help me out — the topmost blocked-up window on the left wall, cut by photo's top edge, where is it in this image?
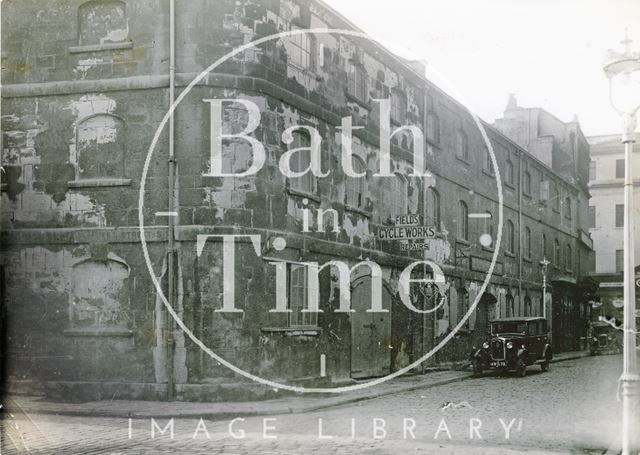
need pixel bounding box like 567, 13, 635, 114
78, 0, 129, 46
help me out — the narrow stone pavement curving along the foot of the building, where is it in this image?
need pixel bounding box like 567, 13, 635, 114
4, 351, 589, 420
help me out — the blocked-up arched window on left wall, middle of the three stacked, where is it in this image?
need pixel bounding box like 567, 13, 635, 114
76, 114, 125, 180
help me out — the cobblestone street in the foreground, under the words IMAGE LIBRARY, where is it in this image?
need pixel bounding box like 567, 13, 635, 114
2, 356, 621, 455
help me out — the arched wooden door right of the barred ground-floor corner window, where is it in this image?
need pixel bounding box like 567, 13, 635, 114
351, 277, 391, 379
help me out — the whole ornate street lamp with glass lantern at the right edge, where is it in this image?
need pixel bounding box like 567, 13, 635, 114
603, 33, 640, 455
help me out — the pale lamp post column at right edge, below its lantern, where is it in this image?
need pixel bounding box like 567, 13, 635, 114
620, 114, 640, 455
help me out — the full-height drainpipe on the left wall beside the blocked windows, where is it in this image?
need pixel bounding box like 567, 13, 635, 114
167, 0, 176, 401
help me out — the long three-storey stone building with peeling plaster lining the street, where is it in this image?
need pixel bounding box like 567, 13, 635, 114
1, 0, 593, 400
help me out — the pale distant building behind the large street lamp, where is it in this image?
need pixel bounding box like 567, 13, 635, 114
587, 134, 640, 319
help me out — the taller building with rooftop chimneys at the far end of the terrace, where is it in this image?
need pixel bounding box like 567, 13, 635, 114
494, 94, 594, 349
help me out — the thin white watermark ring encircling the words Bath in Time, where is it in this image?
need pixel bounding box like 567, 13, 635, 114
138, 28, 503, 393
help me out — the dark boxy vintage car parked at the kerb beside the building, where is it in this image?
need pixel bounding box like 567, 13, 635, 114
470, 317, 553, 377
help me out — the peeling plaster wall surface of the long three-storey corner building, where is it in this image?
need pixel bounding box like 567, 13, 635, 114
0, 0, 592, 400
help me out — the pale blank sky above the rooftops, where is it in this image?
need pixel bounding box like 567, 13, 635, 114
324, 0, 640, 136
